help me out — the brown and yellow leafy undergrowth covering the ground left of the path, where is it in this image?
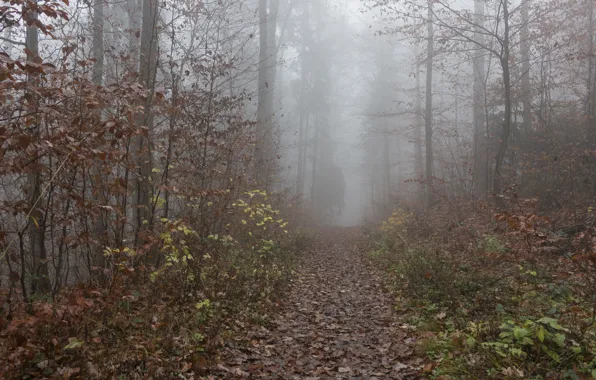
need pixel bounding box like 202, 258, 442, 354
0, 191, 311, 379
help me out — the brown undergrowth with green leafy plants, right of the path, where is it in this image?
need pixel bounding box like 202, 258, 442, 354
368, 200, 596, 380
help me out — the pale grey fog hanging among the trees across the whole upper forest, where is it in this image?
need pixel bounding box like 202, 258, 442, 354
2, 0, 596, 236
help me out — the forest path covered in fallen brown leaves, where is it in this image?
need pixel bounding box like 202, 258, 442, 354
212, 229, 417, 380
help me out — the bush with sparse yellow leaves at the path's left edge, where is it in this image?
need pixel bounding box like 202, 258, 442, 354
152, 190, 296, 308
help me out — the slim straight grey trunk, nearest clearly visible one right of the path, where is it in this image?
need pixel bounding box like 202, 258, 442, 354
424, 0, 434, 207
